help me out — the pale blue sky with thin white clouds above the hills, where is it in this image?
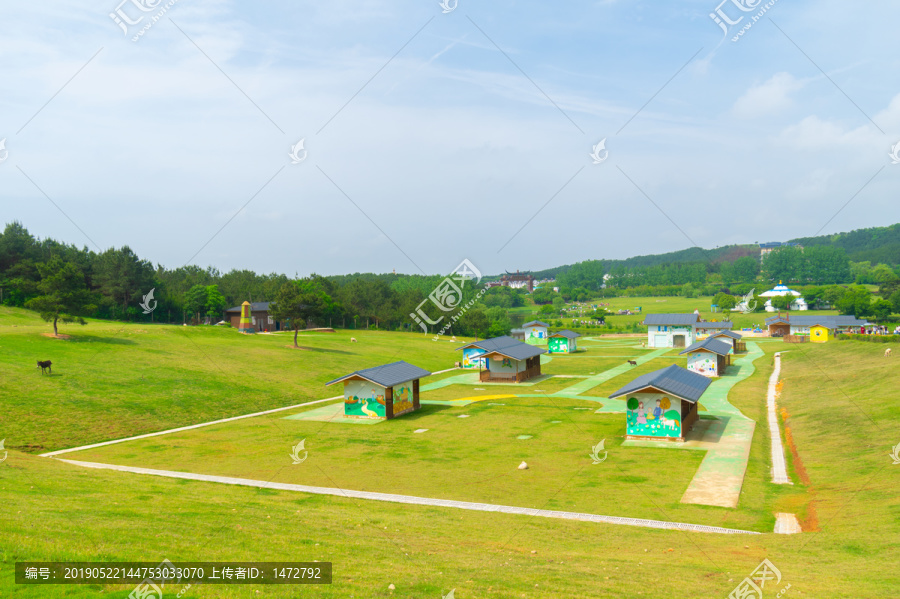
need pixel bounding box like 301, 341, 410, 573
0, 0, 900, 275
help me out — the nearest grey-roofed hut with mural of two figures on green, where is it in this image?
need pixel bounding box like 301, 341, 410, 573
609, 364, 711, 441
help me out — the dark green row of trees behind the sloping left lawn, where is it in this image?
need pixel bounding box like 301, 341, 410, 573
0, 222, 523, 336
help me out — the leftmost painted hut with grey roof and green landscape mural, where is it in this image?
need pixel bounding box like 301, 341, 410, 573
325, 360, 431, 420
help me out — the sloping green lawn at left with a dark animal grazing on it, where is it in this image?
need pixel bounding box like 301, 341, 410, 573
0, 307, 460, 453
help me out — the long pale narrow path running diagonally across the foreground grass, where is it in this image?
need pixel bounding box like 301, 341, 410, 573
60, 459, 760, 535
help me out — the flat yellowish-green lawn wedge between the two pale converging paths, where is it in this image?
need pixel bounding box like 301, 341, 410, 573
65, 397, 752, 530
